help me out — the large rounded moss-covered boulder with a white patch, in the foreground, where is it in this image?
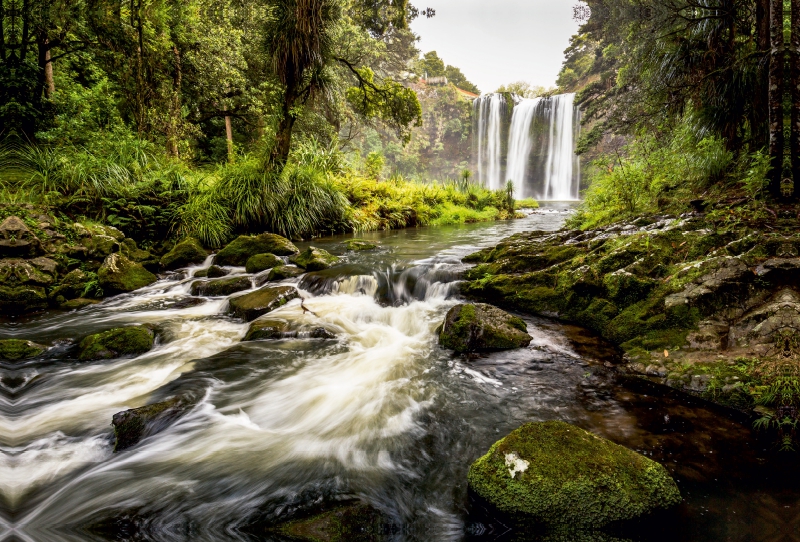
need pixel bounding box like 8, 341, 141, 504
468, 421, 681, 529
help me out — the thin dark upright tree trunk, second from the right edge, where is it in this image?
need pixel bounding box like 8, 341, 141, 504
769, 0, 785, 198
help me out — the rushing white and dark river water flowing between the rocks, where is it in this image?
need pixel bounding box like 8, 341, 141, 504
0, 209, 800, 541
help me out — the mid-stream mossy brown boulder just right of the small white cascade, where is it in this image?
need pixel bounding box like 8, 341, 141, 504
439, 303, 532, 353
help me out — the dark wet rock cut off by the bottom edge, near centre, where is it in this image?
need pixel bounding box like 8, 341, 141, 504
277, 504, 393, 542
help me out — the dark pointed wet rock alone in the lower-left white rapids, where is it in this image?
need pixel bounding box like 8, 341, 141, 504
111, 396, 194, 452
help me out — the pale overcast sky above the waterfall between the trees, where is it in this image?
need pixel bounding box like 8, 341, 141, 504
412, 0, 578, 92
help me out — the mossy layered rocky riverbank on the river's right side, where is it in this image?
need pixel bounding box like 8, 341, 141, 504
462, 208, 800, 422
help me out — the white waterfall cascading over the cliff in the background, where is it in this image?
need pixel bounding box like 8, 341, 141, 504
474, 94, 580, 201
